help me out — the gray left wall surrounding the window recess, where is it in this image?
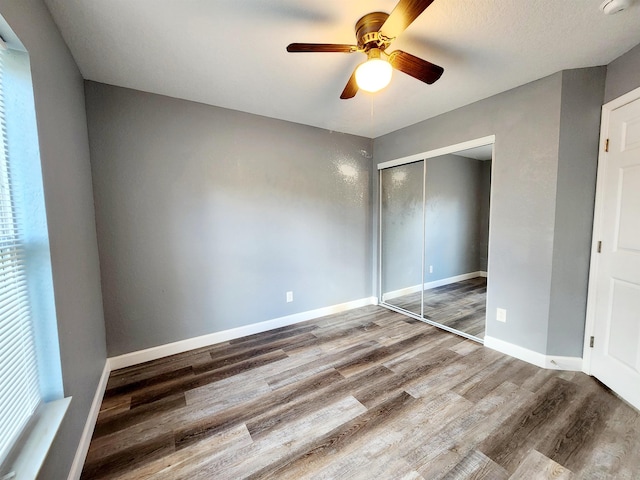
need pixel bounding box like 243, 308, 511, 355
0, 0, 106, 480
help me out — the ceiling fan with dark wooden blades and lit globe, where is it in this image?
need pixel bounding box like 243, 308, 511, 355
287, 0, 444, 100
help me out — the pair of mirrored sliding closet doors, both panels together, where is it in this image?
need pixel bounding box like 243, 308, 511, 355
380, 139, 493, 341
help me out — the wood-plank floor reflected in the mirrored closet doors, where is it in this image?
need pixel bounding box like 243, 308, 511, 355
387, 277, 487, 339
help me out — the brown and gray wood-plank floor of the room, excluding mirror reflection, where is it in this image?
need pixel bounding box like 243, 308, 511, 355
82, 307, 640, 480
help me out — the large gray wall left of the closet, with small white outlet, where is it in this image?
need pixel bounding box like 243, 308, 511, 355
86, 82, 372, 356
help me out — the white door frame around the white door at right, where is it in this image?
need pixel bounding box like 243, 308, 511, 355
582, 87, 640, 375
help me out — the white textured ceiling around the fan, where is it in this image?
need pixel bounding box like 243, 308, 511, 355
45, 0, 640, 138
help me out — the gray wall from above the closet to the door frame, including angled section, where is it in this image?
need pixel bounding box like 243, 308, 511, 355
374, 67, 604, 356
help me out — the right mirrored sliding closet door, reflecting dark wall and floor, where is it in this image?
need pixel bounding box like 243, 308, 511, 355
422, 152, 492, 340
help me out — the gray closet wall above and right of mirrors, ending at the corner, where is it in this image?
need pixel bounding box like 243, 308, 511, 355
374, 73, 562, 353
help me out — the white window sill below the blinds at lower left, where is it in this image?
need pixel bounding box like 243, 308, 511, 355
8, 397, 71, 480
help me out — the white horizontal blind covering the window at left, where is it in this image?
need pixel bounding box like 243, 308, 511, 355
0, 45, 41, 463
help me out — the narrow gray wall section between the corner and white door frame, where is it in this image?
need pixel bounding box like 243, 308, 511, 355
547, 67, 606, 357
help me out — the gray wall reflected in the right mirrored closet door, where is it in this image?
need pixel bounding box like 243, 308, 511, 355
424, 155, 489, 282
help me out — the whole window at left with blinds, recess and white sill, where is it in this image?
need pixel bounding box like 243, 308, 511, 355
0, 20, 70, 479
